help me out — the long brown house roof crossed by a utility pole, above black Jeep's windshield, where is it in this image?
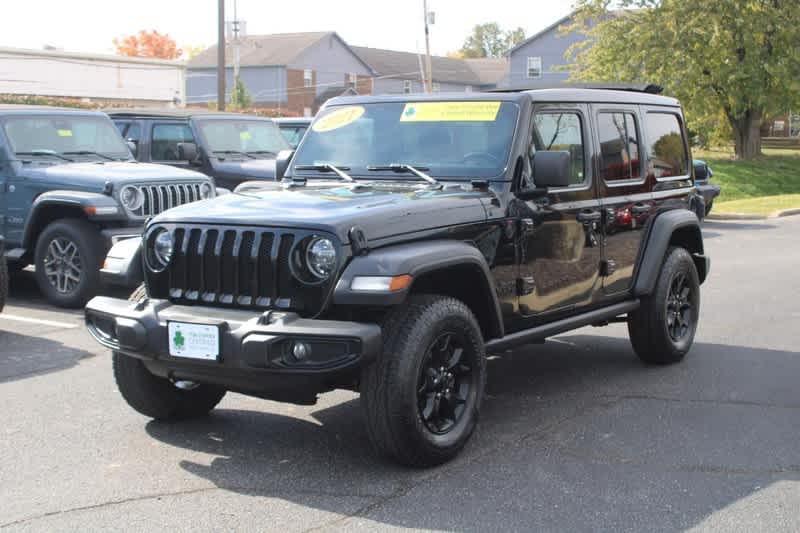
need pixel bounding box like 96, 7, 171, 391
352, 46, 488, 85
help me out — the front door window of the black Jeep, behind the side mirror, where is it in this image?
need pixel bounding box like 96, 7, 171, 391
530, 112, 585, 185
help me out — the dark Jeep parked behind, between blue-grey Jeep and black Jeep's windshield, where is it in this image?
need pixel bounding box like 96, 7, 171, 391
108, 109, 291, 189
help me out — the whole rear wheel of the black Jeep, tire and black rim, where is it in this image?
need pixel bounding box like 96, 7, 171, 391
628, 248, 700, 365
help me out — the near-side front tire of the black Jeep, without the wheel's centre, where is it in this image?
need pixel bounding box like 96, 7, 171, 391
360, 295, 486, 467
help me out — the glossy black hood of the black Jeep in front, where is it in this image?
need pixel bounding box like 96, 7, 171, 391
149, 182, 492, 243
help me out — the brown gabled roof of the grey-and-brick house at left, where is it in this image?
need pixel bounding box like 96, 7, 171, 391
187, 31, 374, 68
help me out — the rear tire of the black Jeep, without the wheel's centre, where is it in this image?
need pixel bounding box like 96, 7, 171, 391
628, 247, 700, 365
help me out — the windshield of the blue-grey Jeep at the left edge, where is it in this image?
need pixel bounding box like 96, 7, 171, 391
4, 115, 130, 159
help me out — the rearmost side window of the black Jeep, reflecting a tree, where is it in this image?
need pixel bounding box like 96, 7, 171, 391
645, 113, 689, 178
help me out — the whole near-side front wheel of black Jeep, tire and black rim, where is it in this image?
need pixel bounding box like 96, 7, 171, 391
361, 295, 486, 466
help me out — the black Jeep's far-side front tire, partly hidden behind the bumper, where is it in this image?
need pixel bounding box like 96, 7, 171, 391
112, 283, 225, 421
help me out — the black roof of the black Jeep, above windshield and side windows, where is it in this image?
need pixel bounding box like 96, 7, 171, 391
326, 88, 680, 107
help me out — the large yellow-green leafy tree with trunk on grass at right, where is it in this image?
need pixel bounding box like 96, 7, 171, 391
567, 0, 800, 159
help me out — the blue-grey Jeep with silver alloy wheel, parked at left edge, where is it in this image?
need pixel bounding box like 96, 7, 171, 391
0, 105, 215, 307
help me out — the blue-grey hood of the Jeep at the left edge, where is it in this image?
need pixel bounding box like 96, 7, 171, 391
20, 161, 208, 190
